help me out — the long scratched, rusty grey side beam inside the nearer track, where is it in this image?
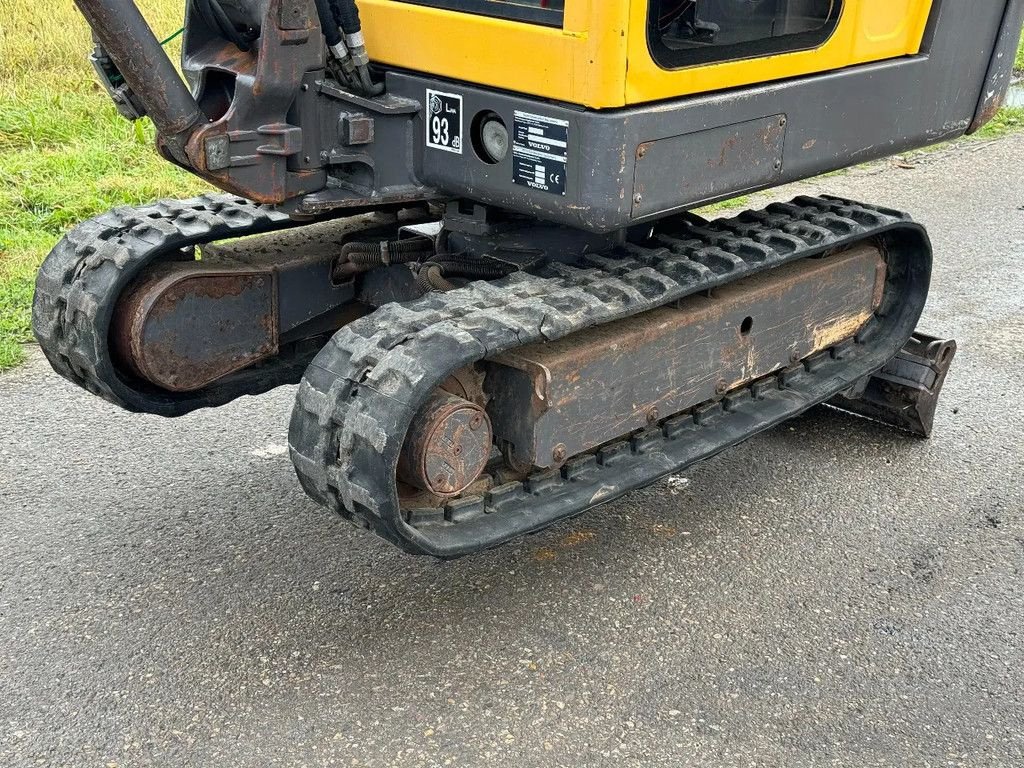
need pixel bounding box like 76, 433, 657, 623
487, 245, 886, 470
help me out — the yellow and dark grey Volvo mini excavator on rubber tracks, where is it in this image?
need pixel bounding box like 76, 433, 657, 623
33, 0, 1024, 558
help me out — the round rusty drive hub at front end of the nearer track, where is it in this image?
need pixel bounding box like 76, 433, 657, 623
398, 391, 492, 498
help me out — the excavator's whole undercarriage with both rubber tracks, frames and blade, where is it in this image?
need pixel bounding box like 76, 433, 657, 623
35, 196, 954, 557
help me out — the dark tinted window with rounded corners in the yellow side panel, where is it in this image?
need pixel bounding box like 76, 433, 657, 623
649, 0, 843, 69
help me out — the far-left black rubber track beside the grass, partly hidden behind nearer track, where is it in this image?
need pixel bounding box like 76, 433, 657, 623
32, 195, 312, 416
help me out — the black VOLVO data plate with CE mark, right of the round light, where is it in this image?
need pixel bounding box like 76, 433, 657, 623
512, 111, 569, 195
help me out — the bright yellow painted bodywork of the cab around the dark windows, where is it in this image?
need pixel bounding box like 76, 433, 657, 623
359, 0, 933, 109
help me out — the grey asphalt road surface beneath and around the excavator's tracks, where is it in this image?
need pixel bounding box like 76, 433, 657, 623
0, 136, 1024, 768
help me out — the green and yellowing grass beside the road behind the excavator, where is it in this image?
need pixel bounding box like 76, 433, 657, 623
0, 9, 1024, 371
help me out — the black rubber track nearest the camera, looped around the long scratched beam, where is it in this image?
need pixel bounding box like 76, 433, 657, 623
289, 198, 931, 557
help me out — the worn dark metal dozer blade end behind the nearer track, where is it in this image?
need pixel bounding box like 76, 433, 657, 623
828, 333, 956, 437
